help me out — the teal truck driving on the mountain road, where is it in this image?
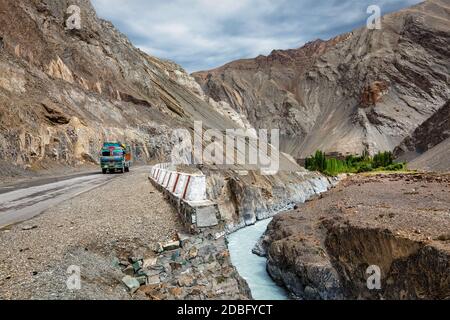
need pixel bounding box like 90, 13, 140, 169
100, 142, 132, 174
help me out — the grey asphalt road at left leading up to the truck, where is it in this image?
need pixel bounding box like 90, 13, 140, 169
0, 172, 118, 229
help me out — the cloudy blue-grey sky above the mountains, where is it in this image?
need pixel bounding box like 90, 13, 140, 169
92, 0, 421, 72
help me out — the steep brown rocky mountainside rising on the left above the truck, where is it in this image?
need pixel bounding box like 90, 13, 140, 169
0, 0, 253, 172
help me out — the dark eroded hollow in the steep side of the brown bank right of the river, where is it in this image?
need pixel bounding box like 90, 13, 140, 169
325, 225, 450, 300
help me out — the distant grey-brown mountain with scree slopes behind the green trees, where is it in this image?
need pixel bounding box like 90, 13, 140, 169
193, 0, 450, 158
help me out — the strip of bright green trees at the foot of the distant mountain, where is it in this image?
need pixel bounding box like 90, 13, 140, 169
305, 151, 406, 176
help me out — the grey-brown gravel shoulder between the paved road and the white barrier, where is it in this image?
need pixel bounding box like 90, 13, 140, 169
0, 170, 182, 299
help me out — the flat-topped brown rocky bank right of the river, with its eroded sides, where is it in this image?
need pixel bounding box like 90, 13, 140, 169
263, 174, 450, 300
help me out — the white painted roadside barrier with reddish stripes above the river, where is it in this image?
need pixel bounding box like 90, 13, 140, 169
150, 163, 207, 202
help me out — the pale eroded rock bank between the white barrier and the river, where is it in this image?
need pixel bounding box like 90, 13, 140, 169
203, 168, 338, 232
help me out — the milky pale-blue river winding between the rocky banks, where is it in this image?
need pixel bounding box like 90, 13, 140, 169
228, 219, 289, 300
